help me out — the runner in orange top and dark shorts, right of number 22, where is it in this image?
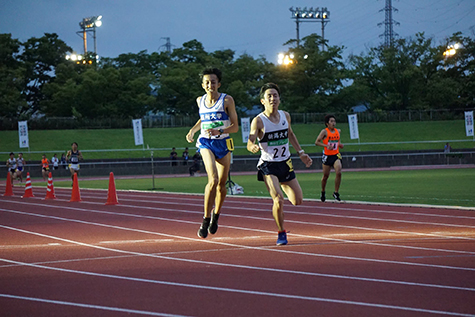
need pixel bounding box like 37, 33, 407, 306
315, 114, 343, 202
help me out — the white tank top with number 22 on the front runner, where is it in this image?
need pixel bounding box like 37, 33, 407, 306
258, 110, 290, 166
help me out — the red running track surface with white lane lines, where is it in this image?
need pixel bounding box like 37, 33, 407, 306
0, 185, 475, 316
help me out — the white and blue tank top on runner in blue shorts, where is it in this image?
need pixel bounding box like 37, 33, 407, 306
198, 93, 231, 140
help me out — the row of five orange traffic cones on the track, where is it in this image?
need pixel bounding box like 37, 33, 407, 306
3, 172, 119, 205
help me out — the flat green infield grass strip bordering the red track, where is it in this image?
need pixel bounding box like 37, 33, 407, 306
55, 168, 475, 207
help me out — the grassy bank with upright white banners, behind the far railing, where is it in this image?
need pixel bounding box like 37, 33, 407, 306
0, 120, 475, 161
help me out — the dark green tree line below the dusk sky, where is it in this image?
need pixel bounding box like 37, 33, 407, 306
0, 33, 475, 119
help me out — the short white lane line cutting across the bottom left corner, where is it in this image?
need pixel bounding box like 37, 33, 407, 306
0, 294, 190, 317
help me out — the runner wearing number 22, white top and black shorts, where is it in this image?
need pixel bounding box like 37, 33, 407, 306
247, 83, 312, 245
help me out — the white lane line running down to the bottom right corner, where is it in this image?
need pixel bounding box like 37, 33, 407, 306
0, 259, 474, 316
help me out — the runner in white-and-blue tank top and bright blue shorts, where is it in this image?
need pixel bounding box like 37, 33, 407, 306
186, 68, 239, 238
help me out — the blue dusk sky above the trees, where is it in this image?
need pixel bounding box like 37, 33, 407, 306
0, 0, 475, 63
